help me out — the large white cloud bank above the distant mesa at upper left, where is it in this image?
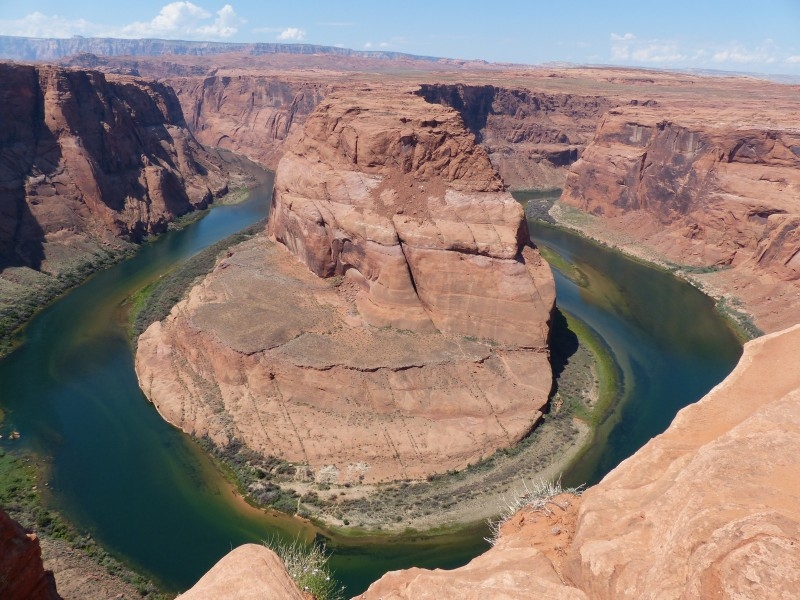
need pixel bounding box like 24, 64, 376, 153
0, 1, 245, 39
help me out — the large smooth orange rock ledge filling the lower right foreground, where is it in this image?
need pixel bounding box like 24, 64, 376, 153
361, 326, 800, 600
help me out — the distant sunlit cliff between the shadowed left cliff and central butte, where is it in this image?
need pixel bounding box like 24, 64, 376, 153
166, 73, 329, 169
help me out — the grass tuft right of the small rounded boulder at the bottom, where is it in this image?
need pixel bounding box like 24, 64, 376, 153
264, 539, 344, 600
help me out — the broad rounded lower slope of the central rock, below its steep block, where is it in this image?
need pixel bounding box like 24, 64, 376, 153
136, 238, 550, 483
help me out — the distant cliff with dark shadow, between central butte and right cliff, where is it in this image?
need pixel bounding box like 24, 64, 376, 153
419, 84, 619, 189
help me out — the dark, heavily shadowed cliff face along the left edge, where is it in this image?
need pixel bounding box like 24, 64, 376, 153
0, 64, 224, 269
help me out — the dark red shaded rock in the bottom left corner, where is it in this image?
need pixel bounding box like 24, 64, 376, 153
0, 509, 61, 600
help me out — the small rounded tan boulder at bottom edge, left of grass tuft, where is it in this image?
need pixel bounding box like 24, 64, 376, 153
178, 544, 306, 600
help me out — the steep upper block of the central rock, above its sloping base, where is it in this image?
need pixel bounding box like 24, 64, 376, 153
269, 90, 553, 348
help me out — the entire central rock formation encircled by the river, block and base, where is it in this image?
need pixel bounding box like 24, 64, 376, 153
136, 90, 554, 482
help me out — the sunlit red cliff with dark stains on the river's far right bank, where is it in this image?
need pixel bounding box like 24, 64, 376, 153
562, 106, 800, 330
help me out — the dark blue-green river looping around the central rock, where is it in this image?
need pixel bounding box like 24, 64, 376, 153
0, 186, 741, 594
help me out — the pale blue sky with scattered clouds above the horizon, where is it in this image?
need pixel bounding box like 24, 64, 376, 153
0, 0, 800, 75
